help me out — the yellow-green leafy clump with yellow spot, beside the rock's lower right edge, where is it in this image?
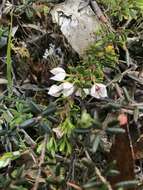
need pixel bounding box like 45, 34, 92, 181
83, 37, 118, 82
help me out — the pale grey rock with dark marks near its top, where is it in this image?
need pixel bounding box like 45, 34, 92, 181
51, 0, 100, 55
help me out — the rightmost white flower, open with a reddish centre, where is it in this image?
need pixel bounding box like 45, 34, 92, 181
90, 83, 108, 99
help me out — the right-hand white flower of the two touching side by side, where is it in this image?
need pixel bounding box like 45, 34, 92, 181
63, 82, 75, 97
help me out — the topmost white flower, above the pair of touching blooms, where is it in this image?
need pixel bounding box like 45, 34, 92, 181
50, 67, 66, 81
